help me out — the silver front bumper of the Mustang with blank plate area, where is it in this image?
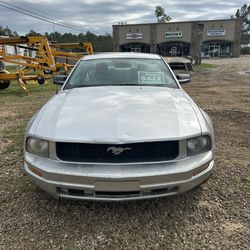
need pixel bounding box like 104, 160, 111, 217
24, 151, 214, 201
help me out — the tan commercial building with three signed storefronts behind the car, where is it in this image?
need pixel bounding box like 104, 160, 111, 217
113, 19, 241, 57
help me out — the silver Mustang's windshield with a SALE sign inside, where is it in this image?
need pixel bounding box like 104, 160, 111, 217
64, 58, 178, 89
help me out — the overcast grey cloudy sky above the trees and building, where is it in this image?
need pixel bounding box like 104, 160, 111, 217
0, 0, 246, 34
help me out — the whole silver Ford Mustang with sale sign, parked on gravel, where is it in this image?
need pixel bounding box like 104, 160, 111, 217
24, 53, 214, 201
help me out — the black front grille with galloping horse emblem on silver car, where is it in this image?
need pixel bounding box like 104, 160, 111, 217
56, 141, 179, 163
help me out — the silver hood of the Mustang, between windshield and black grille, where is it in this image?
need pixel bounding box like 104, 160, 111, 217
33, 86, 201, 144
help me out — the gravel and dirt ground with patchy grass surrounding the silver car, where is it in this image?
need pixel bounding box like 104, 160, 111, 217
0, 57, 250, 249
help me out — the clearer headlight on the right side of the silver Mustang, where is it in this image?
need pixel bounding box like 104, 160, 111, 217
187, 135, 212, 155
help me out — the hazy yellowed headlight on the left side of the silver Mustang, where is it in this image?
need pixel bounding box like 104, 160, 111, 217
26, 137, 49, 157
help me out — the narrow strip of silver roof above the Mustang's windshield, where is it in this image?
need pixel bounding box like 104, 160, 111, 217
82, 52, 161, 60
